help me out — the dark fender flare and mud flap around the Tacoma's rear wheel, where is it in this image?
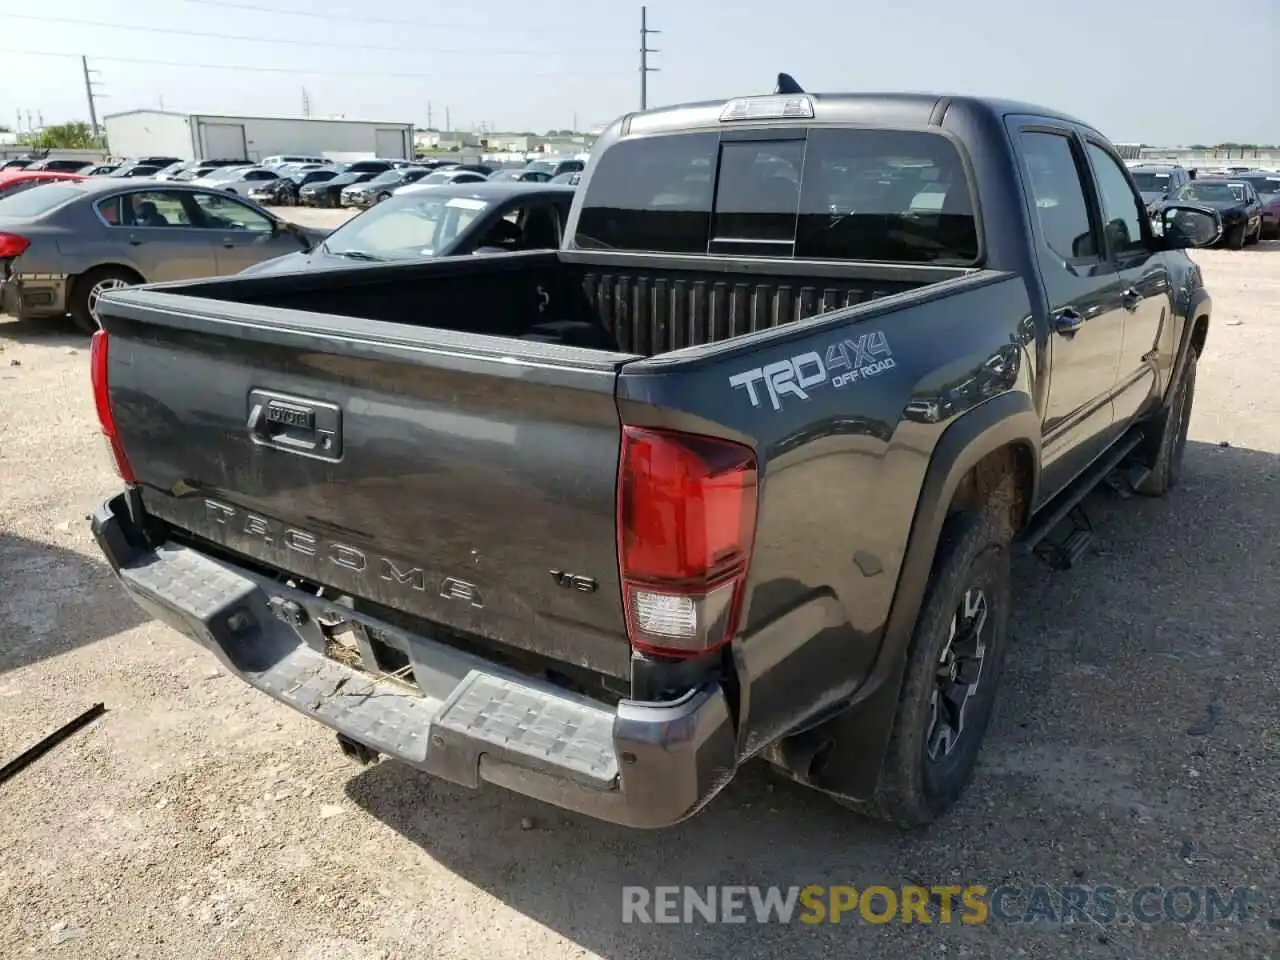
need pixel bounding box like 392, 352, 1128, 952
792, 392, 1041, 800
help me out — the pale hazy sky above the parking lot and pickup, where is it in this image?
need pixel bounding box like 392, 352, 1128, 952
0, 0, 1280, 146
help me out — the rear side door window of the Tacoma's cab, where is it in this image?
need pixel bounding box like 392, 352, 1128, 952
1020, 131, 1098, 260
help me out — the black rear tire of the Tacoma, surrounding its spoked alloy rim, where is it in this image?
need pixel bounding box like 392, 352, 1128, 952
841, 509, 1011, 827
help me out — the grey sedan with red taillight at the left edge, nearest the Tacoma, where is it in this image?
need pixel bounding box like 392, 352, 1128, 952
0, 178, 325, 332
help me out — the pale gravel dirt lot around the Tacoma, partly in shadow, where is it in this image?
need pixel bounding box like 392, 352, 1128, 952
0, 236, 1280, 960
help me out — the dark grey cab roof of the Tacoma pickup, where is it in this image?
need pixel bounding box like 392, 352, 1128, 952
605, 92, 1091, 136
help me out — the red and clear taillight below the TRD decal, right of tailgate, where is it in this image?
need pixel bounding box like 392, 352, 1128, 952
618, 426, 756, 657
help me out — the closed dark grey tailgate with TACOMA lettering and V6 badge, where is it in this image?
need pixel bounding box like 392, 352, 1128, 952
102, 289, 630, 677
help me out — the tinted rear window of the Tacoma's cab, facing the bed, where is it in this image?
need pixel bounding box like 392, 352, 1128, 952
575, 128, 979, 265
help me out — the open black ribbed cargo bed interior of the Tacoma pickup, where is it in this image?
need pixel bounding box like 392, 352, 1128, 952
142, 251, 973, 357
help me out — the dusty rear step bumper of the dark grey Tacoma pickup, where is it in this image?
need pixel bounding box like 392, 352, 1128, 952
91, 495, 736, 827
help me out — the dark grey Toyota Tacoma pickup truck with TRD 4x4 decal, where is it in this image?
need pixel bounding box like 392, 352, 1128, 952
91, 74, 1221, 827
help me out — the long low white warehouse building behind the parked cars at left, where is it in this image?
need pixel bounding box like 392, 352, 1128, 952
102, 110, 413, 160
